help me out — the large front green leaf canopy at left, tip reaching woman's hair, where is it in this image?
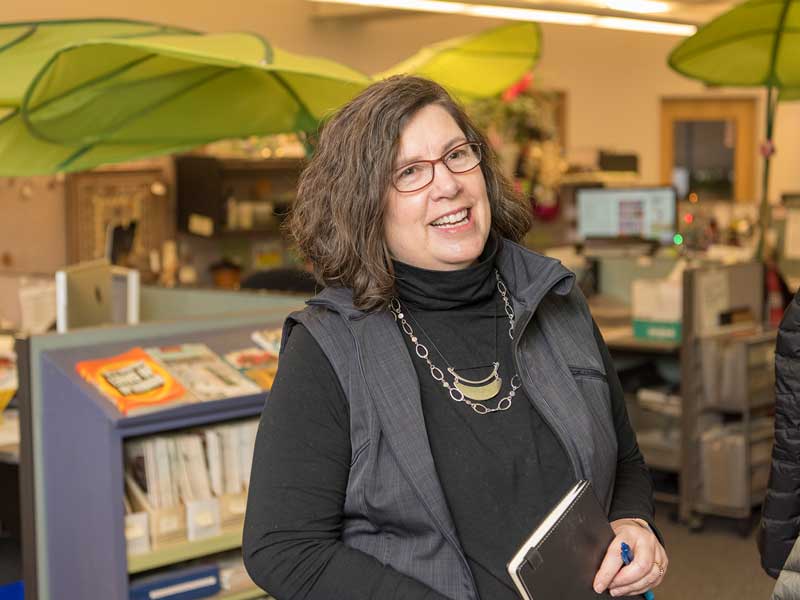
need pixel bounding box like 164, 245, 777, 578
0, 26, 369, 174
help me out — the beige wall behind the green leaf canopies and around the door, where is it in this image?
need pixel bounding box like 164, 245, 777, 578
0, 0, 800, 198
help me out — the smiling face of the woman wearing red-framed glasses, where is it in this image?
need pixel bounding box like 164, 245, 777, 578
383, 104, 492, 271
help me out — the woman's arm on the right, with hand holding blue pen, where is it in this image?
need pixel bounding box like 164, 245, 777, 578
594, 324, 669, 595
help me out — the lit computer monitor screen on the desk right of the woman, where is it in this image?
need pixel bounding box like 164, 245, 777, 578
576, 186, 677, 244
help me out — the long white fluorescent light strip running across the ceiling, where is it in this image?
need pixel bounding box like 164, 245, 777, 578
312, 0, 697, 36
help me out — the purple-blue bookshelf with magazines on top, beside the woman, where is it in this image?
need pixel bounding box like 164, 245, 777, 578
26, 304, 302, 600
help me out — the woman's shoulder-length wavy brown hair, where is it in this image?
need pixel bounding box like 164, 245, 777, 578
287, 75, 532, 311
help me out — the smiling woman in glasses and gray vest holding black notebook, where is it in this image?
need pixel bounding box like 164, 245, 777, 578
243, 77, 667, 600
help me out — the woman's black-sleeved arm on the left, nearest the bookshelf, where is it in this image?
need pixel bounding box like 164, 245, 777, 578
242, 325, 454, 600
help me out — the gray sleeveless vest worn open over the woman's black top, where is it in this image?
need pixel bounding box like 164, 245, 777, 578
284, 241, 617, 600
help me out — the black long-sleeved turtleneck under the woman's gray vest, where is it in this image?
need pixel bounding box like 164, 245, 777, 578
245, 240, 653, 600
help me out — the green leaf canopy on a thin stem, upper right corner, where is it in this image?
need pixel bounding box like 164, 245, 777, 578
669, 0, 800, 255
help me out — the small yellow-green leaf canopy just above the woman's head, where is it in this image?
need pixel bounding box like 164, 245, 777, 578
375, 23, 541, 102
